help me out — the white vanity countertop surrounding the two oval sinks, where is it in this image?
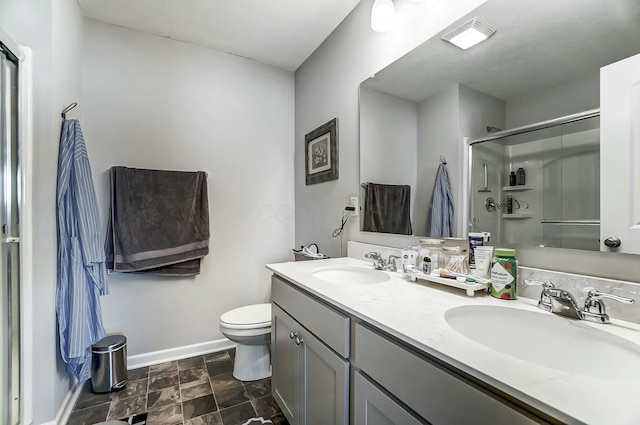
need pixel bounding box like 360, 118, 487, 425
267, 257, 640, 425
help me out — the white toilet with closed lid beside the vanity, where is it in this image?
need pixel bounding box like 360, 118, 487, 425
220, 303, 271, 381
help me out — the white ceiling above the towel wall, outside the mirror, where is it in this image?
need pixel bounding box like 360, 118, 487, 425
78, 0, 360, 71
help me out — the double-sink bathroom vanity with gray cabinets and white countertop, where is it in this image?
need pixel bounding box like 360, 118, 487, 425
267, 258, 640, 425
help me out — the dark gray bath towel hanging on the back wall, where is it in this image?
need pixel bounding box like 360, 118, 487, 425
105, 167, 209, 276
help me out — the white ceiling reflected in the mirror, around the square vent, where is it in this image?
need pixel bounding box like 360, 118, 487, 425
365, 0, 640, 102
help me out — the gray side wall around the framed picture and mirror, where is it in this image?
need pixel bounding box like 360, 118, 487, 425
295, 0, 484, 256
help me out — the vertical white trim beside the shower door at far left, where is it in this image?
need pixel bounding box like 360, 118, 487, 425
18, 44, 34, 424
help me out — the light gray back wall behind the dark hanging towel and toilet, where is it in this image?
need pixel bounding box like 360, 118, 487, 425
82, 20, 294, 355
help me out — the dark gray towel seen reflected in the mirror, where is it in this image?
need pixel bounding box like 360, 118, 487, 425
362, 183, 413, 235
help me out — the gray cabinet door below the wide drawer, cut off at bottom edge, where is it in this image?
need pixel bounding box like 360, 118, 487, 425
353, 372, 425, 425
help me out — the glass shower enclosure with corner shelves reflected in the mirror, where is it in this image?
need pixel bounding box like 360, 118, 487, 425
469, 111, 600, 251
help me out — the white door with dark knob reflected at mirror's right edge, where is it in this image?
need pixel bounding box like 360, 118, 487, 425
600, 55, 640, 254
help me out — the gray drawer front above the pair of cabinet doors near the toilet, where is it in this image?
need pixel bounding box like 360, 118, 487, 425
271, 275, 349, 359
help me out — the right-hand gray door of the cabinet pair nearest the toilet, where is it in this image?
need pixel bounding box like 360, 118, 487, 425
300, 326, 349, 425
